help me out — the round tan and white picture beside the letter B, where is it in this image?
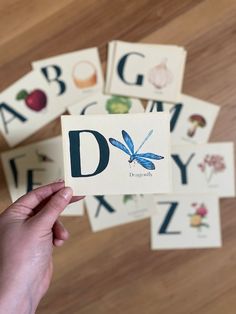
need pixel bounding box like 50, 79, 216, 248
72, 61, 97, 89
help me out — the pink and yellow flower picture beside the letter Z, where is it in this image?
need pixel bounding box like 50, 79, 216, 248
189, 203, 209, 230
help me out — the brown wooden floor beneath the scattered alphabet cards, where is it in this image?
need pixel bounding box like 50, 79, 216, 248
0, 0, 236, 314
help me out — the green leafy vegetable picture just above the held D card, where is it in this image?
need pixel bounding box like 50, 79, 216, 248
106, 96, 132, 113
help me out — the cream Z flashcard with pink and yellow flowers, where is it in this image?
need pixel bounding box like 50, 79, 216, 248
151, 194, 222, 250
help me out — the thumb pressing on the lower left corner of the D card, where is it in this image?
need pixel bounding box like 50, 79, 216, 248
31, 187, 73, 229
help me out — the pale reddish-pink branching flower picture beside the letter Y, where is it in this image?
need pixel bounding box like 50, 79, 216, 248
198, 155, 226, 183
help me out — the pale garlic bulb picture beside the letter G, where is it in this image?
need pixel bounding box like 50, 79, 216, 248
148, 59, 173, 89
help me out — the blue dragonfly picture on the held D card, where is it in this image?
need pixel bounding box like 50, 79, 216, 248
109, 130, 164, 170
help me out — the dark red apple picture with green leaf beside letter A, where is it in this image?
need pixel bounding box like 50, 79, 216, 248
16, 89, 47, 111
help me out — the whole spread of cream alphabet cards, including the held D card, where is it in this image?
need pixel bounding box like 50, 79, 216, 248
0, 41, 235, 250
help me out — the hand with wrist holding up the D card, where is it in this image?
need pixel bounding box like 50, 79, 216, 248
0, 182, 83, 314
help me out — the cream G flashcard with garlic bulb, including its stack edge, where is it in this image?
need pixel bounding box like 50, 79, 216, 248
105, 41, 186, 102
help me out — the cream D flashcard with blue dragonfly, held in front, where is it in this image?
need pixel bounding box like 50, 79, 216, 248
62, 112, 171, 195
